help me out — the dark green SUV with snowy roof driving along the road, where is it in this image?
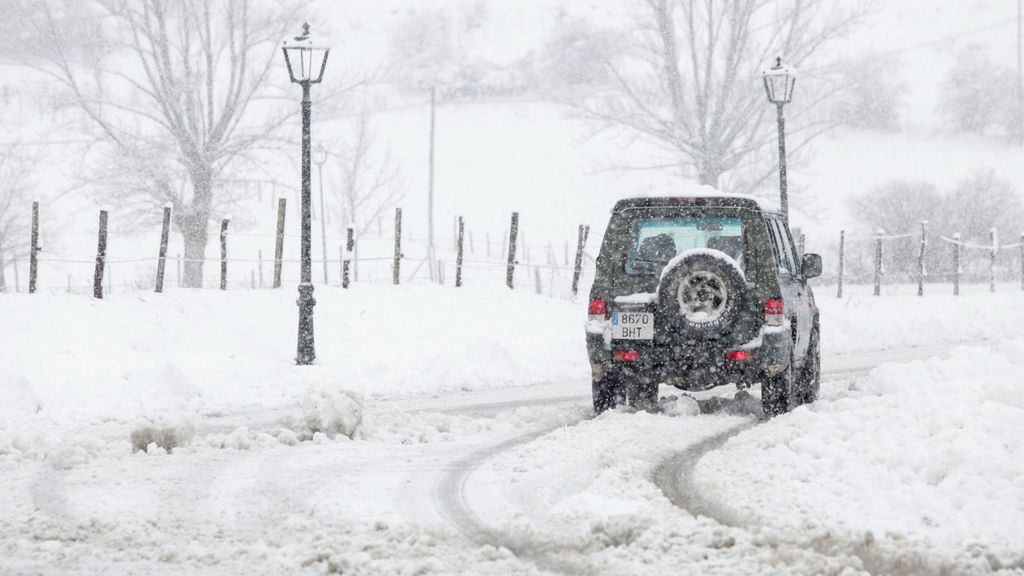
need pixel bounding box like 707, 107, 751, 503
587, 187, 821, 416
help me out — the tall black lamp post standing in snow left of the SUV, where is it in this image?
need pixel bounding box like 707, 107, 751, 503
282, 24, 331, 366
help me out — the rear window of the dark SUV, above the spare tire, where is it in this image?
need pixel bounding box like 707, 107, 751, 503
626, 214, 745, 275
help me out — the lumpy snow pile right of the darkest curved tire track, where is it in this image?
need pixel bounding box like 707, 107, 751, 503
696, 339, 1024, 568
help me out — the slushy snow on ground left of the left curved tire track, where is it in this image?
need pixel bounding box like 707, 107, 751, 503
0, 401, 581, 574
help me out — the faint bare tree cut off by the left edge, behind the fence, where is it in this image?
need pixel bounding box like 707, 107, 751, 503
0, 145, 35, 286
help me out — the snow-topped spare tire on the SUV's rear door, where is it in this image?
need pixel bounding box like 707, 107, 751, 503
657, 249, 746, 339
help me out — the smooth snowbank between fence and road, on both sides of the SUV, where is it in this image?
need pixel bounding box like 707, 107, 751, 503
0, 285, 1024, 445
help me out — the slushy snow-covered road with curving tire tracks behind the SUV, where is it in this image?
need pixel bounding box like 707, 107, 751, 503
0, 347, 1015, 574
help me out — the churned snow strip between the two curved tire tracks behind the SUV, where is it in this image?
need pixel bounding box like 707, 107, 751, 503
466, 403, 917, 574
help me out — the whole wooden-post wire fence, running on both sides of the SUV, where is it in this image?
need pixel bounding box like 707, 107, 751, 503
8, 205, 1024, 298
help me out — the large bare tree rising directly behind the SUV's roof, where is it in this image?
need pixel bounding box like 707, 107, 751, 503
572, 0, 870, 192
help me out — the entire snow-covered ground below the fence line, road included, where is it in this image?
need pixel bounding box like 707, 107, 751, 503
0, 286, 1024, 574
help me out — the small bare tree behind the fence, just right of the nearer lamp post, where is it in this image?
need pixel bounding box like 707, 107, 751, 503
337, 114, 404, 270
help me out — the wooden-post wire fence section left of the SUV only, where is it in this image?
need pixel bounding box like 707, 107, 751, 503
0, 205, 594, 298
